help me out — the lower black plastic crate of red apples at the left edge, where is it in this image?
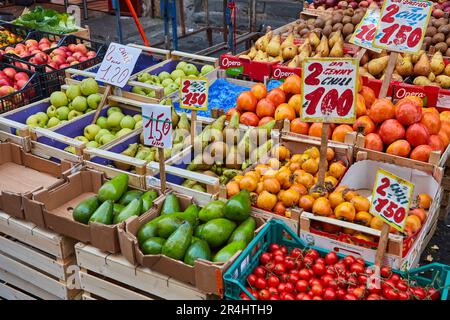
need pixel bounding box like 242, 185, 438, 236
0, 63, 44, 114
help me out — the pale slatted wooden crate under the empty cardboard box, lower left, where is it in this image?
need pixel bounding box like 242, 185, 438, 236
0, 212, 80, 300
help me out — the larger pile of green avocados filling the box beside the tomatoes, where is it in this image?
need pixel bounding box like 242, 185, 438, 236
137, 190, 256, 265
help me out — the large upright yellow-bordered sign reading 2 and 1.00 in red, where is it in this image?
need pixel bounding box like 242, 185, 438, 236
300, 58, 358, 123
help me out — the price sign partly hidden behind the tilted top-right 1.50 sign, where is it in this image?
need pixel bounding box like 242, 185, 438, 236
350, 7, 381, 52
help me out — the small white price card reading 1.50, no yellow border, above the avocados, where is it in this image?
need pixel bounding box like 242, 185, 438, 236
142, 104, 172, 148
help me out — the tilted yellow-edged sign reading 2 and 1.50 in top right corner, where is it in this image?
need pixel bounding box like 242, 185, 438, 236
373, 0, 432, 54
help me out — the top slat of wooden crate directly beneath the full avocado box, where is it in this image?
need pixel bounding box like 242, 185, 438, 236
75, 243, 212, 300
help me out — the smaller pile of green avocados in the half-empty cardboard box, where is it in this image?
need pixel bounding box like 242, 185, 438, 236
72, 173, 158, 224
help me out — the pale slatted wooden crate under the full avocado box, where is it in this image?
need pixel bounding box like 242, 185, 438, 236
75, 243, 215, 300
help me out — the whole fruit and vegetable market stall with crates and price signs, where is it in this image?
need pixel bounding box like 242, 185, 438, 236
0, 0, 450, 300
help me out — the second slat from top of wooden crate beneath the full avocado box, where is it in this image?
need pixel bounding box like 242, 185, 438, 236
79, 271, 153, 300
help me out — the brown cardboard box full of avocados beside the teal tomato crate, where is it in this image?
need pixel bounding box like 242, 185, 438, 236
119, 194, 265, 296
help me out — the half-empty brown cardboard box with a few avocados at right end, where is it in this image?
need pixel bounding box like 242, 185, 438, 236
30, 168, 160, 253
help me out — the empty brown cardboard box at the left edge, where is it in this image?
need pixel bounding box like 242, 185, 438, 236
0, 143, 71, 222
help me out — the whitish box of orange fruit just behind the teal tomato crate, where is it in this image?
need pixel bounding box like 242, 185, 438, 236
300, 160, 442, 269
